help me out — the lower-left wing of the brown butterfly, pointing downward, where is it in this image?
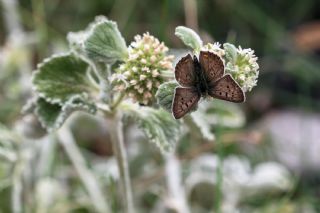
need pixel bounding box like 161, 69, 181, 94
172, 87, 200, 119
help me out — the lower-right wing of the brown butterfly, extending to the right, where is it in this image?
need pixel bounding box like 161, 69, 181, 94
208, 74, 245, 103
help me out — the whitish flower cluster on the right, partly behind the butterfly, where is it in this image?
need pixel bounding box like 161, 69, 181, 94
225, 46, 259, 92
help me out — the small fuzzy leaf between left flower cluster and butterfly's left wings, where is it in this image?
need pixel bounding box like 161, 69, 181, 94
156, 81, 178, 113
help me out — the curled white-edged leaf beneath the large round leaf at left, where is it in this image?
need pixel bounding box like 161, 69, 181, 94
35, 95, 97, 131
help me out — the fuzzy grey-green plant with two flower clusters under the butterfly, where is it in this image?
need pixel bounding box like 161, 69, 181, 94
28, 17, 259, 212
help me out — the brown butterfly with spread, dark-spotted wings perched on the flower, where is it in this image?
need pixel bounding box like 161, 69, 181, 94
172, 51, 245, 119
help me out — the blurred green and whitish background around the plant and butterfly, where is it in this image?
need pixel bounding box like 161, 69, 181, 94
0, 0, 320, 213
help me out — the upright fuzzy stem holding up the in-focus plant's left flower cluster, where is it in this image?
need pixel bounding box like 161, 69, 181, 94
106, 111, 134, 213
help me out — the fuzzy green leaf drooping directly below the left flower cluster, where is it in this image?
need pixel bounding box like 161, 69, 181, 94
127, 107, 181, 153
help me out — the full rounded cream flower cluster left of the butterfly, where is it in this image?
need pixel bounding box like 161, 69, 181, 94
112, 33, 174, 105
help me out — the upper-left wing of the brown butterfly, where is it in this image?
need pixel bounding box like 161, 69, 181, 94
174, 54, 196, 87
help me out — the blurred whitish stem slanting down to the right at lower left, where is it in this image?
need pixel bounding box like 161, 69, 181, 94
58, 124, 111, 213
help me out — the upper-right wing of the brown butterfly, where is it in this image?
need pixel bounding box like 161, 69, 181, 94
199, 51, 224, 84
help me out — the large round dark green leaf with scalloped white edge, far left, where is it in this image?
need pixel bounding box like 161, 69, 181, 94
32, 53, 92, 103
